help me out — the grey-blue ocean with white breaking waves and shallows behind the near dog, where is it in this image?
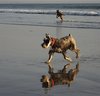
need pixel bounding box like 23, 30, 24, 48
0, 4, 100, 29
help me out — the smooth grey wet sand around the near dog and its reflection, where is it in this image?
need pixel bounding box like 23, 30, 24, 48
0, 24, 100, 96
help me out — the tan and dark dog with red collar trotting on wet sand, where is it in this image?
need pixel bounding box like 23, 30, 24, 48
41, 34, 80, 64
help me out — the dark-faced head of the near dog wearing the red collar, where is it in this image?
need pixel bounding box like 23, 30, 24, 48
41, 34, 51, 48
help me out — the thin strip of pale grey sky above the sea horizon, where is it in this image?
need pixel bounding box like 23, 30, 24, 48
0, 0, 100, 3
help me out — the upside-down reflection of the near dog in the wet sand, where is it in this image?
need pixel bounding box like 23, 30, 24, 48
40, 63, 79, 88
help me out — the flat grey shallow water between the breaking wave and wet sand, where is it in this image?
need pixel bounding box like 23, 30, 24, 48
0, 13, 100, 29
